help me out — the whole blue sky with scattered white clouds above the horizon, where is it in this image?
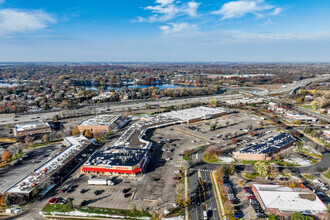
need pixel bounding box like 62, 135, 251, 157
0, 0, 330, 62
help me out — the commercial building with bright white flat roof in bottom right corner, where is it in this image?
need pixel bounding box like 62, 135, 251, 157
252, 184, 327, 217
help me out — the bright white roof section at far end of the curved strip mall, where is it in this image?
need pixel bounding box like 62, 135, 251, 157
162, 106, 226, 121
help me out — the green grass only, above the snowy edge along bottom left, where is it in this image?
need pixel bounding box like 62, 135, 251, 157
42, 204, 152, 217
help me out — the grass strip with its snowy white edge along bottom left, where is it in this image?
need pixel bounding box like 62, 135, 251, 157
40, 204, 152, 220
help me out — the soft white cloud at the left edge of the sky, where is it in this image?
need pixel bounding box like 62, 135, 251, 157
0, 9, 55, 36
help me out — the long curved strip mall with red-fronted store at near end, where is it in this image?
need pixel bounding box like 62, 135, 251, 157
81, 107, 226, 176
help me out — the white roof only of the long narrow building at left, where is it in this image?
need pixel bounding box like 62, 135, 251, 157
6, 136, 89, 193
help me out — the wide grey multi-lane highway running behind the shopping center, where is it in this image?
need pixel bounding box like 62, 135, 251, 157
0, 94, 243, 125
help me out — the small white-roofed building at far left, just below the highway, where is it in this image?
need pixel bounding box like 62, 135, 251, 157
13, 121, 51, 136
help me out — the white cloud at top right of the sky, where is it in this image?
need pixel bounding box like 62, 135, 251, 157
212, 0, 281, 20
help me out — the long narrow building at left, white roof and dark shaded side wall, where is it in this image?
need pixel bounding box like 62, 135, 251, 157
5, 136, 92, 203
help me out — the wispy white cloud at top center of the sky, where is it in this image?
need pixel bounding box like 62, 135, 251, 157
135, 0, 200, 22
